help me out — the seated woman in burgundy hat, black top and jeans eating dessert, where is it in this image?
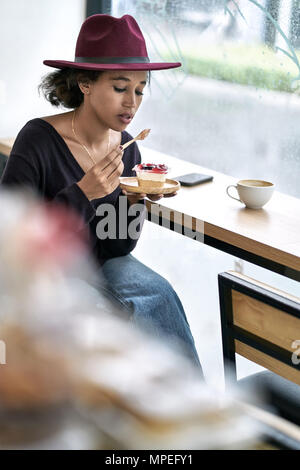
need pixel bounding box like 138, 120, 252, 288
2, 15, 200, 368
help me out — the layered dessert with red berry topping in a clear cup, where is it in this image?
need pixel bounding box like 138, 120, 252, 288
133, 163, 168, 192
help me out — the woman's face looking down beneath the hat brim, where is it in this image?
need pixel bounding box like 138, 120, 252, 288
81, 70, 147, 131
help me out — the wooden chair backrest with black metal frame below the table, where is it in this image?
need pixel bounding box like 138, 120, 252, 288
219, 271, 300, 385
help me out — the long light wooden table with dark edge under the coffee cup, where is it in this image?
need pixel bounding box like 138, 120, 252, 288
140, 146, 300, 281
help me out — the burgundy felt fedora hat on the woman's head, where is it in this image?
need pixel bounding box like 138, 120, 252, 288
43, 14, 181, 70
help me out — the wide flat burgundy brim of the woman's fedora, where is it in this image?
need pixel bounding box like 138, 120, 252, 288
43, 60, 181, 71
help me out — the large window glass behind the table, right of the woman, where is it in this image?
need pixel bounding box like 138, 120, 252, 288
112, 0, 300, 197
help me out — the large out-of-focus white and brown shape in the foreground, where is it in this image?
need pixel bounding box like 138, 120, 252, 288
0, 189, 258, 449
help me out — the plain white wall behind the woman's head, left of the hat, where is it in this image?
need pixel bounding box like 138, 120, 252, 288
0, 0, 86, 137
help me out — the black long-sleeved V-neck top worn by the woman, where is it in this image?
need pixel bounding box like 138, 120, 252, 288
1, 118, 141, 265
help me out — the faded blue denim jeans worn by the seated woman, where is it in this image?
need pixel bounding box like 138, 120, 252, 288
90, 254, 202, 374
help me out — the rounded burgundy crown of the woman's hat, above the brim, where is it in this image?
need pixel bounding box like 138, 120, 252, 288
75, 14, 148, 57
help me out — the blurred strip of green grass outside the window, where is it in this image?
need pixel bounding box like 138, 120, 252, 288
171, 43, 300, 93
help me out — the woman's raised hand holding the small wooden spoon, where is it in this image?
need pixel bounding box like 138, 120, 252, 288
77, 145, 124, 201
